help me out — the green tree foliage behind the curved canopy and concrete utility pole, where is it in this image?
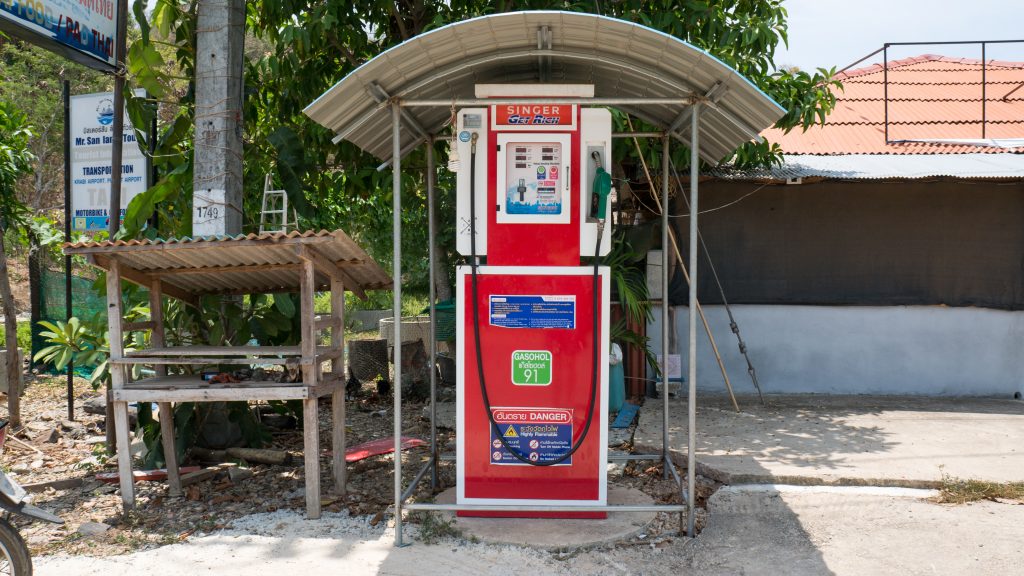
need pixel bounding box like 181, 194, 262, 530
119, 0, 838, 289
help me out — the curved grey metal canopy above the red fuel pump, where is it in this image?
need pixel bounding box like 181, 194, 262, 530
304, 11, 785, 162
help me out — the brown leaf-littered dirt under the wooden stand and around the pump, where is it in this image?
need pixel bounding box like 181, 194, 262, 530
3, 376, 717, 557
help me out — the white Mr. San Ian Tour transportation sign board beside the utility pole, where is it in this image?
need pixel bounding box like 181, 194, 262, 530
70, 90, 150, 232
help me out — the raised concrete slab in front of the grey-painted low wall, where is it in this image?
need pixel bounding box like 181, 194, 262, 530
635, 395, 1024, 488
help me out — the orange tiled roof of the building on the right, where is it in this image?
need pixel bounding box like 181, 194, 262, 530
761, 54, 1024, 155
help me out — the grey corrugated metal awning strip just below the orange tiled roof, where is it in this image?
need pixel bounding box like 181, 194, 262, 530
708, 154, 1024, 181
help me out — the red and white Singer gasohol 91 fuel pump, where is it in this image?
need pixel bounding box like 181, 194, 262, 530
455, 84, 611, 518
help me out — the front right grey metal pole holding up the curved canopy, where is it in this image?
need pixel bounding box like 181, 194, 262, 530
686, 102, 700, 538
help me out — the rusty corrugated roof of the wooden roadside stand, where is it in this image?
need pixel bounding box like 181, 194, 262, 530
63, 230, 391, 299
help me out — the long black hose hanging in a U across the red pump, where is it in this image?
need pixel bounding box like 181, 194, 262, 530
469, 132, 604, 466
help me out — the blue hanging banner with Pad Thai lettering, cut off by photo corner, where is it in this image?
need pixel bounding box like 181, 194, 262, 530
0, 0, 118, 70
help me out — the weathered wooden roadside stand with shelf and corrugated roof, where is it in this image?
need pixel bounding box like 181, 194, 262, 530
65, 230, 391, 519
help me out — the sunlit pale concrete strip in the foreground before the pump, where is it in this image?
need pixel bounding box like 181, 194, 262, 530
36, 486, 1024, 576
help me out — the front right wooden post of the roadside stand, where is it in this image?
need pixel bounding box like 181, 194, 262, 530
299, 260, 321, 520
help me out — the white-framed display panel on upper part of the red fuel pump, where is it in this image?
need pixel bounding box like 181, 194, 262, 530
505, 142, 566, 215
